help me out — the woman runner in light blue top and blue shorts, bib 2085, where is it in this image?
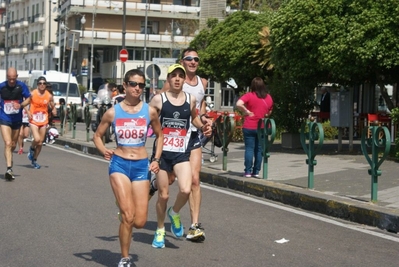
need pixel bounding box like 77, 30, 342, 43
93, 69, 163, 267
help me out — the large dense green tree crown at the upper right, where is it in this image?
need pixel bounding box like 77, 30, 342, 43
271, 0, 399, 109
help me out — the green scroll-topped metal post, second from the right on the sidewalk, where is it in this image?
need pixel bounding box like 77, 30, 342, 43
300, 117, 324, 189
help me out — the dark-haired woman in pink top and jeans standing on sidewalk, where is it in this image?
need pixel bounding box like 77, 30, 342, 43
237, 77, 273, 178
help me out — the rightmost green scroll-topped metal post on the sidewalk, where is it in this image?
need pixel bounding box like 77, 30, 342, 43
361, 121, 391, 202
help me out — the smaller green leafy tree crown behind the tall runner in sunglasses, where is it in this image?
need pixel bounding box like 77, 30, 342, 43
190, 11, 270, 88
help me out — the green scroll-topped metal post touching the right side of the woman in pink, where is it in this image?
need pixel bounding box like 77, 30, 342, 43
257, 115, 276, 179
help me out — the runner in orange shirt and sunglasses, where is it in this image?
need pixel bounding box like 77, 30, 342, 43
28, 76, 57, 169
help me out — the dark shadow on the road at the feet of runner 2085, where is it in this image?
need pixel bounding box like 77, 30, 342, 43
73, 249, 138, 267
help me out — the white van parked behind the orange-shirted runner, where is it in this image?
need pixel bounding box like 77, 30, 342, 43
29, 70, 83, 121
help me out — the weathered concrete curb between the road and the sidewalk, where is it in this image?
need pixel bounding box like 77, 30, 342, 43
56, 137, 399, 233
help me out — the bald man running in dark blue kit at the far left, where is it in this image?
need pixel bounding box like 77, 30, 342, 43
0, 67, 30, 181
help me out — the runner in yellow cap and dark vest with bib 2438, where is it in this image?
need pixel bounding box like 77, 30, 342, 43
150, 64, 212, 248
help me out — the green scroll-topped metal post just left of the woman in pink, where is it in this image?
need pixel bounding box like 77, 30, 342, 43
215, 112, 235, 171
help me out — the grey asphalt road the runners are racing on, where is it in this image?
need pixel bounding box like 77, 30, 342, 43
0, 143, 399, 267
